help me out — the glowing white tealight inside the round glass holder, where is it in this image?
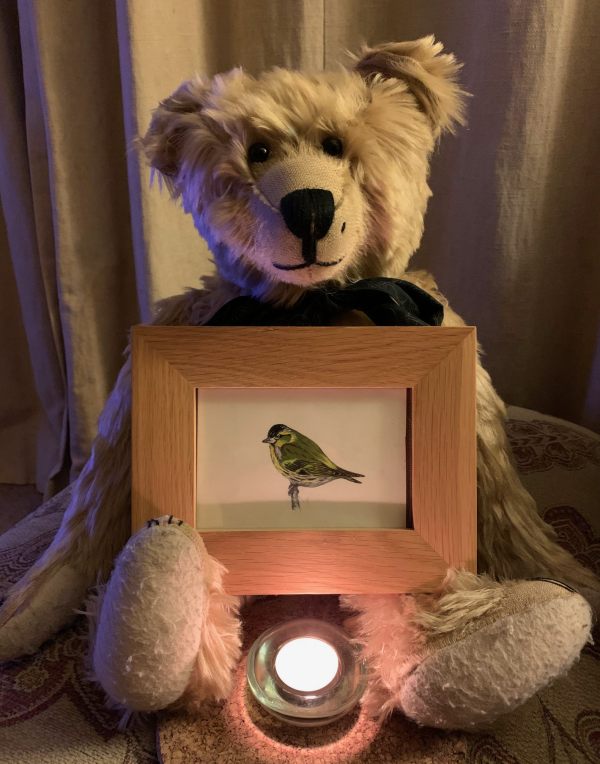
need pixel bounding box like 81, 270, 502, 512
275, 637, 340, 692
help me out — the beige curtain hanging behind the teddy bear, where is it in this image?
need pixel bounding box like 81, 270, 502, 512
0, 0, 600, 493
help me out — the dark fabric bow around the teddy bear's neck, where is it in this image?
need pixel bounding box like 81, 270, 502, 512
207, 278, 444, 326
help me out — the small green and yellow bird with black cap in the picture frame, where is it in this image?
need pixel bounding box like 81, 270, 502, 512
263, 424, 364, 509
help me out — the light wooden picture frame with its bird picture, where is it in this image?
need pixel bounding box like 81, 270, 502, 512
132, 326, 477, 594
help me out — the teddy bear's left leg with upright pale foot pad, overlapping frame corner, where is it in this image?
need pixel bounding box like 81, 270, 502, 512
88, 517, 240, 712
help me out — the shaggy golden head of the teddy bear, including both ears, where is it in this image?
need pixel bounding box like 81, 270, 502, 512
141, 37, 464, 300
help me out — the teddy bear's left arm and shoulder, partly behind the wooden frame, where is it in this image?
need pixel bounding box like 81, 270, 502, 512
0, 276, 237, 660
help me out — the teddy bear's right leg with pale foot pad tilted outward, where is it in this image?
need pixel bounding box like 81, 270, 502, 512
344, 572, 592, 730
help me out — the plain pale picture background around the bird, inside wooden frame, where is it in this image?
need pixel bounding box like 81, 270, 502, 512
196, 388, 407, 530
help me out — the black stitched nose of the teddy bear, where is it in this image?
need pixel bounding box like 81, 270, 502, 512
279, 188, 335, 262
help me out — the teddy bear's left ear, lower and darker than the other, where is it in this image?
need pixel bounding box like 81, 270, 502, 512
139, 77, 210, 192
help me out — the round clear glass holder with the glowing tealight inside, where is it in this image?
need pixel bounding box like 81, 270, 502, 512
247, 618, 367, 727
